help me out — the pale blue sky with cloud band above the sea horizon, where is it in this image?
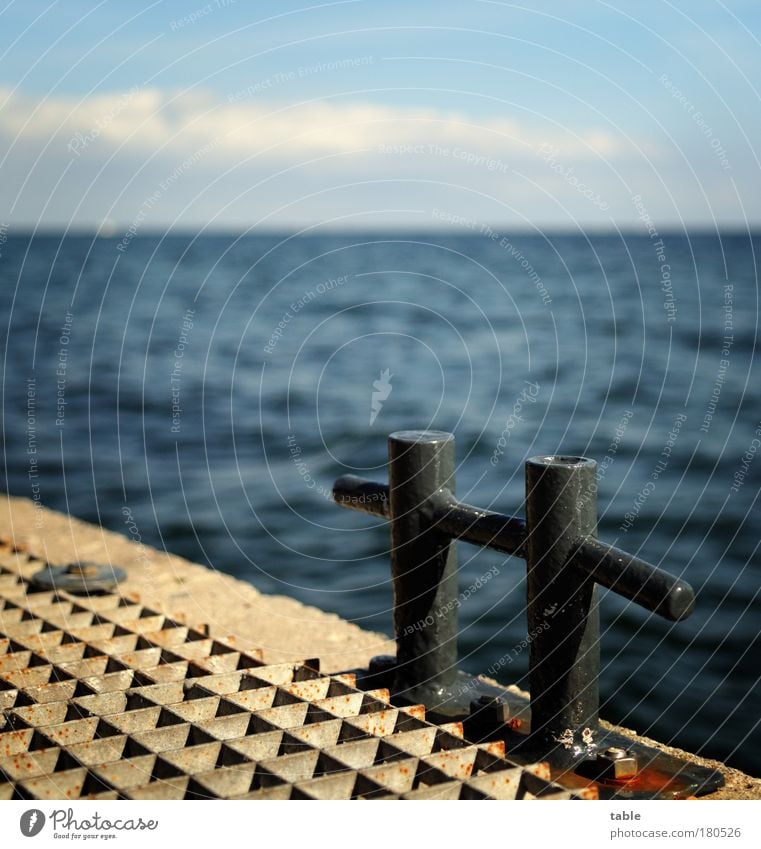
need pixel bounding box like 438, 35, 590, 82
0, 0, 761, 234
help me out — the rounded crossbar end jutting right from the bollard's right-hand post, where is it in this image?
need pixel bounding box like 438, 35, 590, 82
571, 537, 695, 622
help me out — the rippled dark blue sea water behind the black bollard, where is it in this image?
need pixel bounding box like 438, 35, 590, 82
0, 233, 761, 774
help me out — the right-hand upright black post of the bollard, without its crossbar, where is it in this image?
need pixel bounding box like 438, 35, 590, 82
526, 456, 600, 766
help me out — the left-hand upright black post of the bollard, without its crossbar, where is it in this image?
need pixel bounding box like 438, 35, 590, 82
388, 430, 457, 707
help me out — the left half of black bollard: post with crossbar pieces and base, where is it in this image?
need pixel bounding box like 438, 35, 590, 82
333, 431, 525, 718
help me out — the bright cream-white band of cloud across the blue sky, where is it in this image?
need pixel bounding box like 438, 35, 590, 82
0, 89, 622, 163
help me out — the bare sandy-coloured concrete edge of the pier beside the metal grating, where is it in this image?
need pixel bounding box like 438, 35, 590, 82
0, 496, 761, 799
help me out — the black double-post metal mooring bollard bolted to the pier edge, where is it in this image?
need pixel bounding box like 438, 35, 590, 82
333, 431, 722, 794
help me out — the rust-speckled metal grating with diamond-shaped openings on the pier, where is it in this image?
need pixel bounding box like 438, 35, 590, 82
0, 545, 574, 799
